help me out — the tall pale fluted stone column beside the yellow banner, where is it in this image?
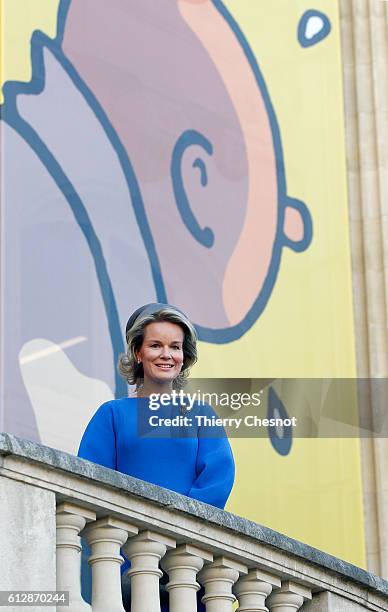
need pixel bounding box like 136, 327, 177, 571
339, 0, 388, 578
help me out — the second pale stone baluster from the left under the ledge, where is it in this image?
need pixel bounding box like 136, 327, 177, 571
82, 516, 138, 612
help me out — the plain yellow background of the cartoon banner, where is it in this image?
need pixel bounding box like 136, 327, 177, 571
1, 0, 365, 566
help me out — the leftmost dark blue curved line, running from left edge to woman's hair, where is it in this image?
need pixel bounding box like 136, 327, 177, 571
2, 105, 127, 397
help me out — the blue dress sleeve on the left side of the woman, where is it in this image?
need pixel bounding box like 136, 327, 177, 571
78, 402, 117, 470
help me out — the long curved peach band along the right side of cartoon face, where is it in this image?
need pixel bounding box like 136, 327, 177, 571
178, 0, 278, 325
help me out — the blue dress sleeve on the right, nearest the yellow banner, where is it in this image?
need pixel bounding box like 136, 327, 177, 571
188, 406, 235, 508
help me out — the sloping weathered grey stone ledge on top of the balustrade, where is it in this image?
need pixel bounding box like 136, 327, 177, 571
0, 433, 388, 595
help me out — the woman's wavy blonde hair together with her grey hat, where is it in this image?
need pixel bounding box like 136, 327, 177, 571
118, 306, 198, 390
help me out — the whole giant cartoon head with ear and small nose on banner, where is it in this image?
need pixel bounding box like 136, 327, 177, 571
63, 0, 312, 343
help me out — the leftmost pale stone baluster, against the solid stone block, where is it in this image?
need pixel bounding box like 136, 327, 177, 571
57, 502, 96, 612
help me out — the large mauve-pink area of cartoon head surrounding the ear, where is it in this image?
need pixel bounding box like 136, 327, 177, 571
63, 0, 249, 328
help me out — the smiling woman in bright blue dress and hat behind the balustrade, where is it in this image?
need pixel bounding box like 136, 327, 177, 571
78, 304, 234, 608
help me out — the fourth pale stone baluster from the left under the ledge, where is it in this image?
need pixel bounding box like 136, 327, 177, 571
161, 544, 213, 612
